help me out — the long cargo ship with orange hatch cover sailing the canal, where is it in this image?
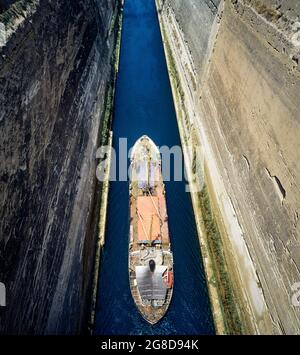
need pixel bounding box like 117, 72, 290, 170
128, 136, 174, 325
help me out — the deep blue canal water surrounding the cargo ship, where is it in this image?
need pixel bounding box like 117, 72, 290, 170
96, 0, 215, 335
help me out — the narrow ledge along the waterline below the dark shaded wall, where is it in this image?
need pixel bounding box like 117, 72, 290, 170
88, 0, 124, 334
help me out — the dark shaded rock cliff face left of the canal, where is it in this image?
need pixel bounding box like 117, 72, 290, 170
0, 0, 119, 334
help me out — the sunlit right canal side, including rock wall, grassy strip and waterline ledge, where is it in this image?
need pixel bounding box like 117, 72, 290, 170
157, 0, 300, 334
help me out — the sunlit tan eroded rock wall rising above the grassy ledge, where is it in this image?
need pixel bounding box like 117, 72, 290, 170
161, 0, 300, 334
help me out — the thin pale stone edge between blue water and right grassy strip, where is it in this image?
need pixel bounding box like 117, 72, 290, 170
155, 0, 226, 335
